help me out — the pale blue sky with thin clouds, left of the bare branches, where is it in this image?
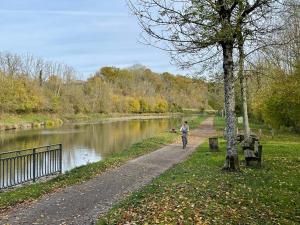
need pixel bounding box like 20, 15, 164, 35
0, 0, 188, 77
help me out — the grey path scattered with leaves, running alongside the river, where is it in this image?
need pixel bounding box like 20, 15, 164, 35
0, 118, 215, 225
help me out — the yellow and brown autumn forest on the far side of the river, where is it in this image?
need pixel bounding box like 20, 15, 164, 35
0, 53, 223, 114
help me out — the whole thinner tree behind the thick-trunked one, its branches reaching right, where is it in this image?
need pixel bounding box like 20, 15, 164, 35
237, 0, 300, 144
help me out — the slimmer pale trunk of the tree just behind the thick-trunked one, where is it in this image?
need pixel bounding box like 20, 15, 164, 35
238, 39, 250, 142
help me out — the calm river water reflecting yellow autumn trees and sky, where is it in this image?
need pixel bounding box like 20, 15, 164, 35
0, 118, 182, 171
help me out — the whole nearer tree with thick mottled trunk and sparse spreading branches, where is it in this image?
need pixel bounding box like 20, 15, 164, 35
129, 0, 273, 170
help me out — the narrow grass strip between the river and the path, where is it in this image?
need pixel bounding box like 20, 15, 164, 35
0, 117, 203, 210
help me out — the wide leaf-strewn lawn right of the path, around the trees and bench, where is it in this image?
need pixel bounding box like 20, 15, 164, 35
98, 120, 300, 225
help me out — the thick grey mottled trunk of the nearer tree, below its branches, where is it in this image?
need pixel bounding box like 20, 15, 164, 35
222, 43, 239, 170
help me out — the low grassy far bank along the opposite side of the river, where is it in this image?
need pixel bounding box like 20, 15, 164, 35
0, 113, 192, 131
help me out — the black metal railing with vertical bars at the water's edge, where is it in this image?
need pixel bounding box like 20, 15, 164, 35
0, 144, 62, 189
